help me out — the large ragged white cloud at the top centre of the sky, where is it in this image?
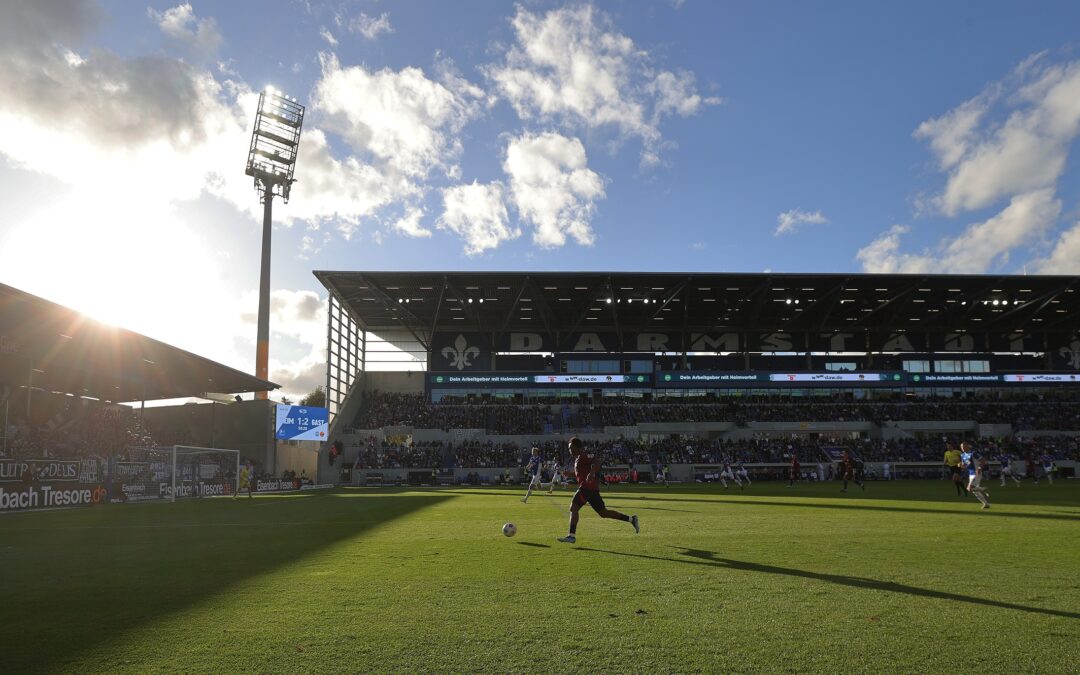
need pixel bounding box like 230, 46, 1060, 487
486, 4, 719, 166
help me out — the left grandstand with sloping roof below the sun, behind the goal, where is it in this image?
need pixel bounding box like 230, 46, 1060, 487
0, 284, 287, 496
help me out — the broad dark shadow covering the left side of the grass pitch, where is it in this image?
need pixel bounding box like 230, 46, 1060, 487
0, 494, 451, 673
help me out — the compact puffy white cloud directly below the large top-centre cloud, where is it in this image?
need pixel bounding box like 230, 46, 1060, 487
502, 133, 604, 248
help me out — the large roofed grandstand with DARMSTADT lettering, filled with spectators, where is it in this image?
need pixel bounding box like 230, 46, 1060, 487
314, 271, 1080, 485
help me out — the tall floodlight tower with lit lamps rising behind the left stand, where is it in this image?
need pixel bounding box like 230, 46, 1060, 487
244, 86, 303, 400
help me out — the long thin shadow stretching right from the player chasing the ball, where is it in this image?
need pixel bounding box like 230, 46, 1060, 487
577, 546, 1080, 619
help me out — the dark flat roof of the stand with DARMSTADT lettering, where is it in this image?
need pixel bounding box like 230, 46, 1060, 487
314, 271, 1080, 346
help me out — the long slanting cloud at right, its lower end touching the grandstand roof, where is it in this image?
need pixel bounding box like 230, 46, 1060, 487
855, 190, 1062, 274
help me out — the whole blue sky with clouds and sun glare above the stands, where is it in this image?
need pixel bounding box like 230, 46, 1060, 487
0, 0, 1080, 393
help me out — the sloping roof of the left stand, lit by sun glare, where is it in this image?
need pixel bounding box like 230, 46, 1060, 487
0, 284, 279, 402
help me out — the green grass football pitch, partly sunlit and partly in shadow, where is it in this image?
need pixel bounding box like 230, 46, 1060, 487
0, 481, 1080, 673
